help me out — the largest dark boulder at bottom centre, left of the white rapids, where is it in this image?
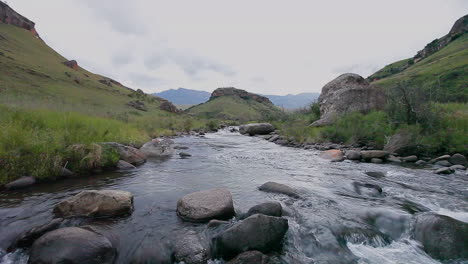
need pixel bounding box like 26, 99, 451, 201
213, 214, 289, 258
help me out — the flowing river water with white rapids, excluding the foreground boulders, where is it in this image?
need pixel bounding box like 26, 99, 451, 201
0, 131, 468, 264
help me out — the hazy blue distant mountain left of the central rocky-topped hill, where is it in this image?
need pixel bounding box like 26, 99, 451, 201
154, 88, 211, 105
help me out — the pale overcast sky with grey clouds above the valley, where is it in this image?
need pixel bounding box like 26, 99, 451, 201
8, 0, 468, 94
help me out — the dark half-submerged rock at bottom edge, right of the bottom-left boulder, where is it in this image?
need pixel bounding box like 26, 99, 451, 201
130, 241, 174, 264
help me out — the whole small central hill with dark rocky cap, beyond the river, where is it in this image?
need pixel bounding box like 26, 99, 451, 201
187, 87, 283, 122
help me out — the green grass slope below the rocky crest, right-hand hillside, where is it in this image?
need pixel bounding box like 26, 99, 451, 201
371, 34, 468, 102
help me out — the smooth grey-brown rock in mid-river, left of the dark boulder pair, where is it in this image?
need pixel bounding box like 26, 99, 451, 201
177, 188, 235, 222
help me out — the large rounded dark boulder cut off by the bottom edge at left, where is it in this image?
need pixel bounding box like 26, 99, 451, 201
28, 227, 117, 264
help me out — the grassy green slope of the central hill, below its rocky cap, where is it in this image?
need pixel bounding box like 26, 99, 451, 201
187, 96, 283, 122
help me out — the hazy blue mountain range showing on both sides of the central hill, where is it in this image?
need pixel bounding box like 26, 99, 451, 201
155, 88, 320, 109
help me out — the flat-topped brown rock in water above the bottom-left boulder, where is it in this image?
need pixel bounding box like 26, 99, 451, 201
54, 190, 133, 217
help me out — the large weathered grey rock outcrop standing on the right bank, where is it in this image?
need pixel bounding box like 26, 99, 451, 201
312, 73, 385, 126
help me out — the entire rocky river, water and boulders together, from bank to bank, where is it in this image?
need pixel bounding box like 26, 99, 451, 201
0, 129, 468, 264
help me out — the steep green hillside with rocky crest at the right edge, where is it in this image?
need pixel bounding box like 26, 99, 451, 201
368, 15, 468, 102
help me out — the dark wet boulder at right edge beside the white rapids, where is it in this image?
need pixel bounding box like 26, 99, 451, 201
413, 213, 468, 260
